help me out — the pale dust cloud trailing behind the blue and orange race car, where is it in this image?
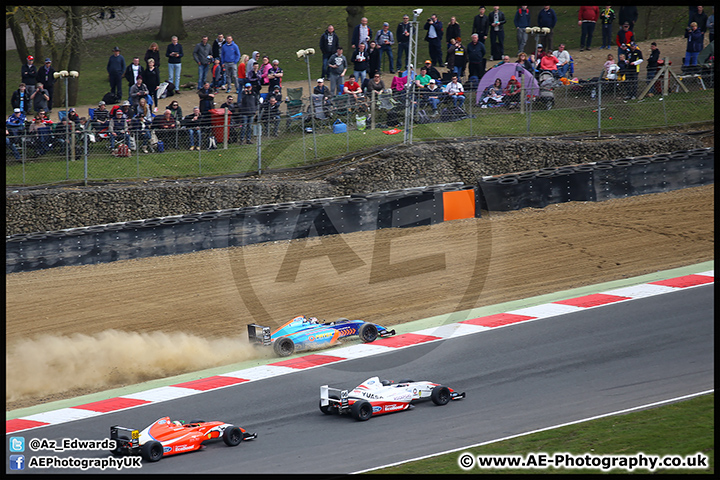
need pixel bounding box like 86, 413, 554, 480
5, 330, 262, 402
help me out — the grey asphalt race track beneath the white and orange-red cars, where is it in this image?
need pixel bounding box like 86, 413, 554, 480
6, 285, 714, 474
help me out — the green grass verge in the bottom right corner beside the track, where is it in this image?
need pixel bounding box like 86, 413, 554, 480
370, 394, 715, 474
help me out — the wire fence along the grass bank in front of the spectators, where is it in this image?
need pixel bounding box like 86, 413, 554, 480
6, 69, 714, 185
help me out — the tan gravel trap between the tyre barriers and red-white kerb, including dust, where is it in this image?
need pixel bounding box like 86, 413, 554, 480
6, 185, 714, 410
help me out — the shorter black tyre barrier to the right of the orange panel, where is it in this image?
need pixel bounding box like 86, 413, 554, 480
478, 148, 715, 212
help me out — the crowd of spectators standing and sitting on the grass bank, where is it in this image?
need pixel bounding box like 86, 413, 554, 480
6, 5, 714, 157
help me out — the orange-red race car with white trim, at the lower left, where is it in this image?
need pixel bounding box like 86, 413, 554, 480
110, 417, 257, 462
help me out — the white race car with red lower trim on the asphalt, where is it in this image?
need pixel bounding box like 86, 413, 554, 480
320, 377, 465, 421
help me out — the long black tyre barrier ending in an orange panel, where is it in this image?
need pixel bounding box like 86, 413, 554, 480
5, 183, 479, 274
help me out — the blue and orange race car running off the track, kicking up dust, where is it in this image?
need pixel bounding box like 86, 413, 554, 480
248, 315, 395, 357
